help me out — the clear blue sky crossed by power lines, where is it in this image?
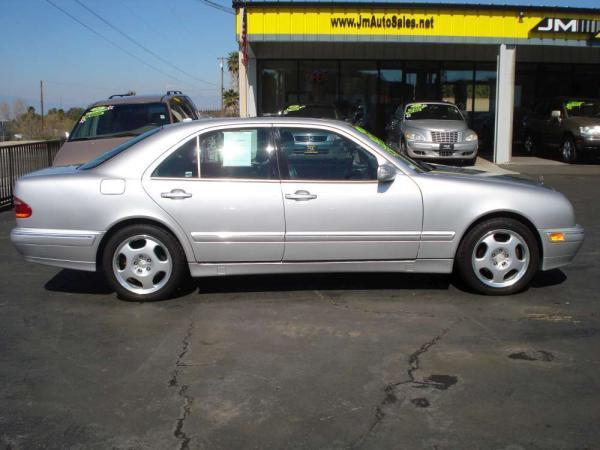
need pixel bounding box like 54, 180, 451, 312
0, 0, 599, 109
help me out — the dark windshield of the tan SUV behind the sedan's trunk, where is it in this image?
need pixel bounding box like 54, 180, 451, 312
69, 103, 169, 141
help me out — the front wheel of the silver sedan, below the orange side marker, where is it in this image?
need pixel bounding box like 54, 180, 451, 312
455, 217, 540, 295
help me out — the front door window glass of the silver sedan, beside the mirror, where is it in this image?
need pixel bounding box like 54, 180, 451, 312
279, 128, 378, 181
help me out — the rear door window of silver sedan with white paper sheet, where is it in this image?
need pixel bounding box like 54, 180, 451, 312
200, 127, 279, 180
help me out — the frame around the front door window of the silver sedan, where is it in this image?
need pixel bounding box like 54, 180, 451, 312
272, 123, 388, 184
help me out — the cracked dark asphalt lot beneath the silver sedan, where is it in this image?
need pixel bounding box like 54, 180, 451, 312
0, 166, 600, 449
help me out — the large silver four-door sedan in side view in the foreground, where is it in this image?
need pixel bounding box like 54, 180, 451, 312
11, 117, 583, 301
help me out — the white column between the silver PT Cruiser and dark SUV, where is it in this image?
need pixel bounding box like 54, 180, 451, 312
494, 44, 517, 164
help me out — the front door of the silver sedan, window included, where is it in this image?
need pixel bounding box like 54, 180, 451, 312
275, 126, 422, 261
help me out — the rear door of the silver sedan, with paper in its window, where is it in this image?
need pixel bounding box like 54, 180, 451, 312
144, 127, 285, 262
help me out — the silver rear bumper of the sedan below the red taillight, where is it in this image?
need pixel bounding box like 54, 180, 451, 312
10, 227, 103, 272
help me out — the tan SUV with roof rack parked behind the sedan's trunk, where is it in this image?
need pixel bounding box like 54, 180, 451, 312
53, 91, 198, 166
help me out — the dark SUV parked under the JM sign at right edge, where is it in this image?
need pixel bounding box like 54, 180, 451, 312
523, 97, 600, 163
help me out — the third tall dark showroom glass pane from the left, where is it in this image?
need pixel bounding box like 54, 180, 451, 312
339, 61, 379, 130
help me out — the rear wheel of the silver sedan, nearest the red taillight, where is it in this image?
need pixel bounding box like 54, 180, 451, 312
102, 224, 189, 302
